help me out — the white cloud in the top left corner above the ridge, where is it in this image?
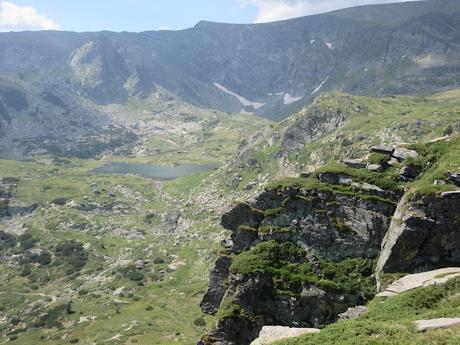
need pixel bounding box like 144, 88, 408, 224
0, 1, 59, 31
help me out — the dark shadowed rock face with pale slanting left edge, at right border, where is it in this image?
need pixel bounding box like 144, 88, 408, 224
377, 192, 460, 272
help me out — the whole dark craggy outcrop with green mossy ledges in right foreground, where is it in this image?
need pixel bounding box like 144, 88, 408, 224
198, 140, 460, 345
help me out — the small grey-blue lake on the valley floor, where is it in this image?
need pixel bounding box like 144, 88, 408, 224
91, 162, 219, 181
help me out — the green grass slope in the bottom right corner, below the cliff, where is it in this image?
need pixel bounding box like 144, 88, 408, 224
276, 278, 460, 345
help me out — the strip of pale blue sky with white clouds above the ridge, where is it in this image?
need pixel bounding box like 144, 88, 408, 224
0, 0, 420, 32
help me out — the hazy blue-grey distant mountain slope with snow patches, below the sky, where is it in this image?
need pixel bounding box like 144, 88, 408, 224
0, 0, 460, 155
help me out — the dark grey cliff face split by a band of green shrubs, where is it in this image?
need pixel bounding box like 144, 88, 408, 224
200, 181, 397, 345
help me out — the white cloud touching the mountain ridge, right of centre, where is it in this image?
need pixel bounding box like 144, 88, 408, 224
244, 0, 420, 23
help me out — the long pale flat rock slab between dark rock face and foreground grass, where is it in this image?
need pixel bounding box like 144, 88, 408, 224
377, 267, 460, 298
